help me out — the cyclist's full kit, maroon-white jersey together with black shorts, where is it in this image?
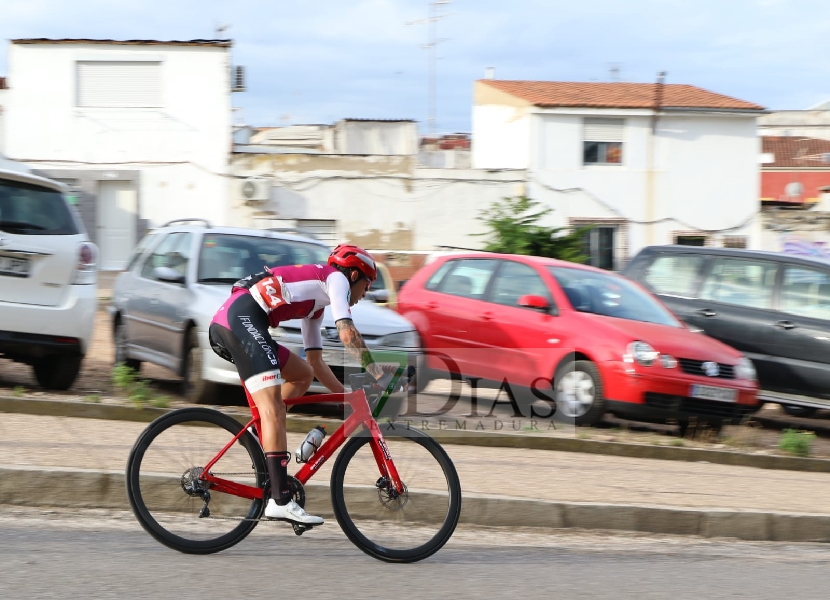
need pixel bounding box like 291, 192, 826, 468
209, 265, 352, 392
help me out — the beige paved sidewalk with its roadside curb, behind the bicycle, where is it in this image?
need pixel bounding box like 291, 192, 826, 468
0, 412, 830, 541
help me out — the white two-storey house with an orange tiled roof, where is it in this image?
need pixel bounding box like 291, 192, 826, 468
472, 79, 764, 268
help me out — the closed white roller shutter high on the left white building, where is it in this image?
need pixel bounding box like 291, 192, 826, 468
77, 61, 163, 108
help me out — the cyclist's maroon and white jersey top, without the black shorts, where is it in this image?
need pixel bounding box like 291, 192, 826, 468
233, 265, 352, 349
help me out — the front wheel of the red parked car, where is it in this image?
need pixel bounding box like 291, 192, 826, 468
554, 360, 605, 425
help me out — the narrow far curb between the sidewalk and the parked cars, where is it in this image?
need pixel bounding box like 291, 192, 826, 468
0, 396, 830, 473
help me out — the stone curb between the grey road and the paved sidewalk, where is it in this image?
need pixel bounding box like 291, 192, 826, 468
0, 467, 830, 542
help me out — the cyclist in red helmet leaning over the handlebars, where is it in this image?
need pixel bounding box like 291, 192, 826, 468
209, 244, 391, 525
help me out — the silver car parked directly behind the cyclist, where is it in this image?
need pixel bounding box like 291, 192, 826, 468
109, 219, 420, 402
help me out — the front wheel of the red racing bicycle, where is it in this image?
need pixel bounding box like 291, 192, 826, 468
331, 424, 461, 562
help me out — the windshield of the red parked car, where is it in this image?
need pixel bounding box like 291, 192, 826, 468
548, 267, 682, 327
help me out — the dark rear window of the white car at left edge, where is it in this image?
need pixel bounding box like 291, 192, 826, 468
0, 180, 79, 235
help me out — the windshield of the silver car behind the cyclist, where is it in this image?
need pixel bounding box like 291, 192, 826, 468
198, 233, 330, 283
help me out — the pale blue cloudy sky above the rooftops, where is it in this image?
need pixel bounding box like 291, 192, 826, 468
0, 0, 830, 132
